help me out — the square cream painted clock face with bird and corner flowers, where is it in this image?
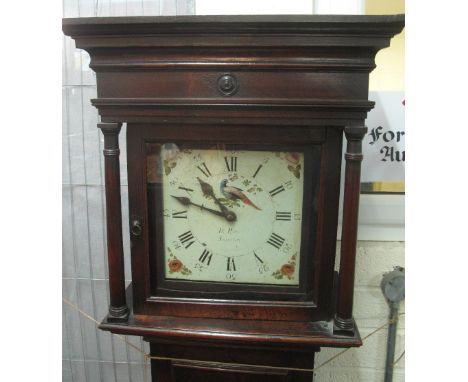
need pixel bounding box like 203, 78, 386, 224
161, 144, 304, 285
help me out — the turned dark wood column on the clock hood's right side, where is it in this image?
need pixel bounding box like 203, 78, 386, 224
334, 126, 367, 335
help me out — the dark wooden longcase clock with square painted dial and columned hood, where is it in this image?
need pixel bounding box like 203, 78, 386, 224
63, 15, 404, 381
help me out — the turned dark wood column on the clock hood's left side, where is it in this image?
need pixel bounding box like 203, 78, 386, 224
98, 123, 128, 321
